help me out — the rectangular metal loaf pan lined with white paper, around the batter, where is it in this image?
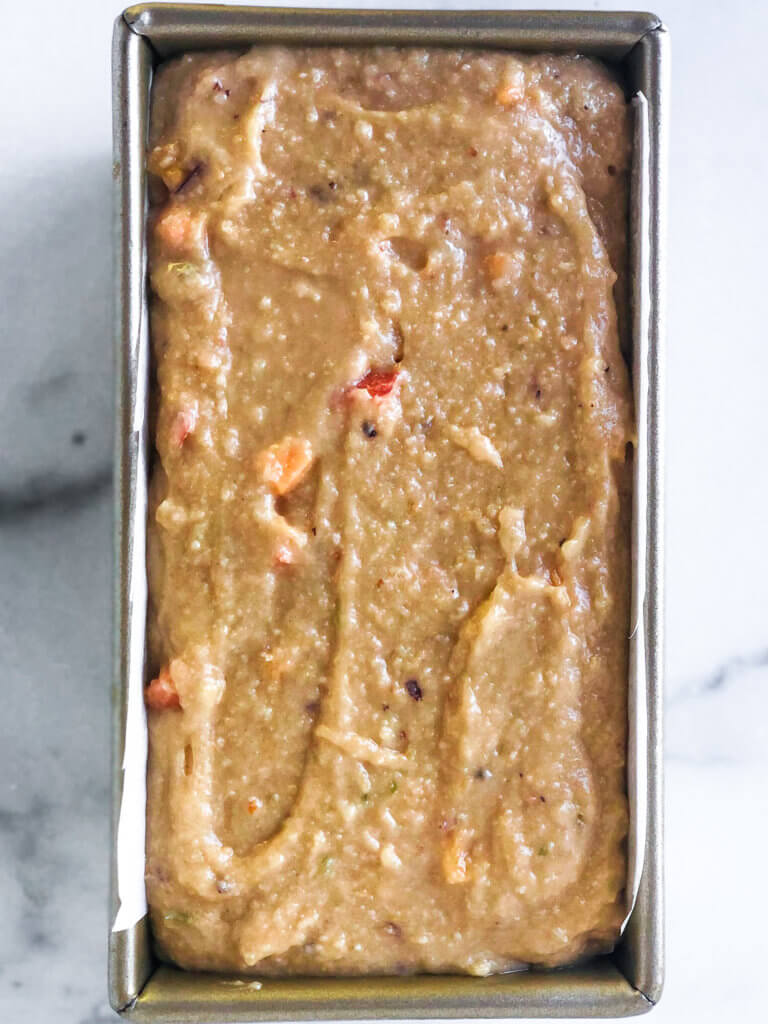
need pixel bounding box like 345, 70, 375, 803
109, 4, 669, 1022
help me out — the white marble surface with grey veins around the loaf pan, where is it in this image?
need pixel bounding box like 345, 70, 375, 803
0, 0, 768, 1024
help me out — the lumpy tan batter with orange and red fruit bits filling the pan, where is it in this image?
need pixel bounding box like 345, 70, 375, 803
146, 48, 632, 974
